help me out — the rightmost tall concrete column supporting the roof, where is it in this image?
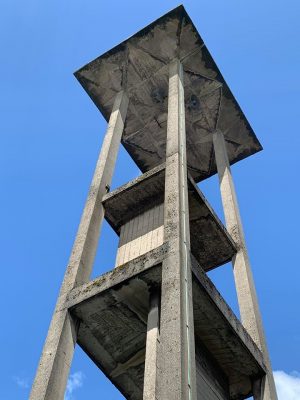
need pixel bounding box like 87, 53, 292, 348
213, 131, 277, 400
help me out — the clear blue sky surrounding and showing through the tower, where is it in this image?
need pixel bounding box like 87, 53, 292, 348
0, 0, 300, 400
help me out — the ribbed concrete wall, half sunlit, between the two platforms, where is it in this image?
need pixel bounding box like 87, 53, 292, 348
115, 204, 164, 267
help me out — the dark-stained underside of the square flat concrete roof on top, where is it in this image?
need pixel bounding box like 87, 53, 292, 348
75, 6, 262, 182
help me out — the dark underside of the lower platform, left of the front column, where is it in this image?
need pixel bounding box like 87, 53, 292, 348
71, 265, 161, 400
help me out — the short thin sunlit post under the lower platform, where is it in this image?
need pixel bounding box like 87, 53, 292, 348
143, 291, 159, 400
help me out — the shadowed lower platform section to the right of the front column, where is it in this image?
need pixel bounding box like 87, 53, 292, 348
192, 258, 266, 399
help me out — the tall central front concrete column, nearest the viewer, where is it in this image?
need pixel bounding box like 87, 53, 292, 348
158, 60, 196, 400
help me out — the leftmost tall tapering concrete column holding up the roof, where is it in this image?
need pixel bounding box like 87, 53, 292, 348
30, 92, 128, 400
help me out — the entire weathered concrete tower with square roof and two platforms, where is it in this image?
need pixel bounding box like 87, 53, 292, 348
30, 6, 277, 400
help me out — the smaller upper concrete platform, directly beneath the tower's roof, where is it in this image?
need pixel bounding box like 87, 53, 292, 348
103, 164, 236, 271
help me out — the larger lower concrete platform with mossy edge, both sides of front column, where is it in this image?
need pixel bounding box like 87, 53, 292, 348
67, 248, 265, 400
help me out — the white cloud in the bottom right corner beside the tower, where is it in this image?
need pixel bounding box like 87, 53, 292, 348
274, 371, 300, 400
